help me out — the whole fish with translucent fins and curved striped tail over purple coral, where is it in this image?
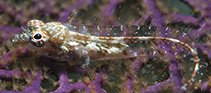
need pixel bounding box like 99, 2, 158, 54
13, 20, 199, 85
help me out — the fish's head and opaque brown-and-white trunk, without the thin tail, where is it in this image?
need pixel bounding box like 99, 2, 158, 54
13, 20, 129, 61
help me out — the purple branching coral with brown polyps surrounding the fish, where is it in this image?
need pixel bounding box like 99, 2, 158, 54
0, 0, 211, 93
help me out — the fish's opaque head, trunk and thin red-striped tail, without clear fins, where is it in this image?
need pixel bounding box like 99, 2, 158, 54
12, 12, 199, 83
